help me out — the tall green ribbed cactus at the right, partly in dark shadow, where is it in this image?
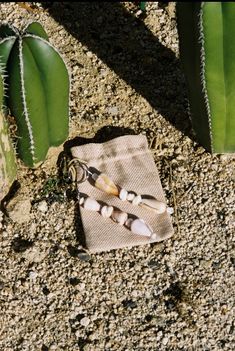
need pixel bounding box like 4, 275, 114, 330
176, 2, 235, 153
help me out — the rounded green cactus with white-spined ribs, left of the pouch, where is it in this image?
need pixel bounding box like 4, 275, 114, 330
0, 22, 69, 167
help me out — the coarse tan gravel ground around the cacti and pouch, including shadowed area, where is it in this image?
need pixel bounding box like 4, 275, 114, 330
0, 2, 235, 351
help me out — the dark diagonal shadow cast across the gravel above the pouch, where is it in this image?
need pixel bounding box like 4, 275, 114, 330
42, 2, 192, 138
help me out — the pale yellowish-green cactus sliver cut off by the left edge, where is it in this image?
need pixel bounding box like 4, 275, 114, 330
0, 68, 16, 202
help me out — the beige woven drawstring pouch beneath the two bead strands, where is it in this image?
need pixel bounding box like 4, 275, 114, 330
71, 135, 173, 252
